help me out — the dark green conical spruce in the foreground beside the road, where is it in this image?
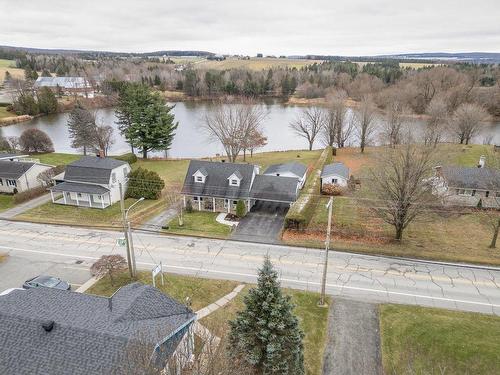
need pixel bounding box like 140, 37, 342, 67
228, 257, 304, 375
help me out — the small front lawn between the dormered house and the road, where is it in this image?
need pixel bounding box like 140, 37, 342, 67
164, 211, 231, 238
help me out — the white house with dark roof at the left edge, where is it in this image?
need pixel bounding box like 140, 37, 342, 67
0, 158, 53, 194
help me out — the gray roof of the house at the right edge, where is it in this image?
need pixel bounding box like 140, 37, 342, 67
442, 166, 500, 190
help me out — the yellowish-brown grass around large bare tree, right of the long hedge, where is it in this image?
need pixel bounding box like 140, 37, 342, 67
284, 144, 500, 265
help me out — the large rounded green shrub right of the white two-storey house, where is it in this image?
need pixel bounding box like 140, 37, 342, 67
126, 168, 165, 199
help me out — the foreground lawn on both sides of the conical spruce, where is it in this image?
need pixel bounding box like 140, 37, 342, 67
201, 285, 331, 375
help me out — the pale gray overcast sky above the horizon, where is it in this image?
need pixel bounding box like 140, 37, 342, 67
0, 0, 500, 55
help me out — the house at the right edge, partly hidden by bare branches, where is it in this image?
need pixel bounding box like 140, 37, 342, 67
432, 157, 500, 208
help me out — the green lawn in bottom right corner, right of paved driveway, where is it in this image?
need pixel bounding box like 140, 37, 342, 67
380, 305, 500, 375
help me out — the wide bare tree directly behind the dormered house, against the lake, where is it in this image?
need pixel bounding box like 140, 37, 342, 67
203, 101, 265, 162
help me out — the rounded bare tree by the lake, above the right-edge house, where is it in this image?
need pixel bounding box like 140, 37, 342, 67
452, 103, 488, 145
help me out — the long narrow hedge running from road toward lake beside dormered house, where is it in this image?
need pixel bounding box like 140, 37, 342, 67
285, 147, 333, 230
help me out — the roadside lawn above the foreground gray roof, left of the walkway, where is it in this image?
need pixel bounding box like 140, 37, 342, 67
86, 271, 238, 311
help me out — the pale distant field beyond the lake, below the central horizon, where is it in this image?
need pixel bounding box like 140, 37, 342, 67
189, 57, 322, 70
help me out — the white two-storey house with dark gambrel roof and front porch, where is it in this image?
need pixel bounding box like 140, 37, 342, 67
50, 156, 130, 208
